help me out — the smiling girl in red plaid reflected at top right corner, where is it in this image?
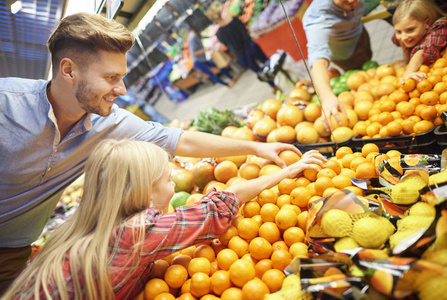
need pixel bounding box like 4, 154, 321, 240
392, 0, 447, 81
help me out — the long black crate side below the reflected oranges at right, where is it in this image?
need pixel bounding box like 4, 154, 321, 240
352, 127, 440, 154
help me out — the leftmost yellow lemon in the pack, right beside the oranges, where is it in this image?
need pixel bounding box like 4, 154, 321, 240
321, 209, 352, 237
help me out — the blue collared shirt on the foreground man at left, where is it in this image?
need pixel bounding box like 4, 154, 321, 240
0, 78, 183, 247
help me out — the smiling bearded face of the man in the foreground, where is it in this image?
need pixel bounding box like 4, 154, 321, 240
75, 50, 127, 117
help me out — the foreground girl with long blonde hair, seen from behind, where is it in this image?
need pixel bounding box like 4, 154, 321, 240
2, 140, 326, 300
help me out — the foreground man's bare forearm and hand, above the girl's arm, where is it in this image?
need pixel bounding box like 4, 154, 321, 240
174, 131, 301, 167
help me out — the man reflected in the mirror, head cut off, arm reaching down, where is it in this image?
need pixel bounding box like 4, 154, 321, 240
303, 0, 372, 129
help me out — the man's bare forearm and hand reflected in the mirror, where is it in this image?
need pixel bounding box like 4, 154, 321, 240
311, 58, 346, 130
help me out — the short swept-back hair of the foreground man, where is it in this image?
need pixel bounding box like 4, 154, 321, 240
47, 13, 135, 76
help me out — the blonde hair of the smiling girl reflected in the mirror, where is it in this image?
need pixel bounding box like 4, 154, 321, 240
393, 0, 445, 62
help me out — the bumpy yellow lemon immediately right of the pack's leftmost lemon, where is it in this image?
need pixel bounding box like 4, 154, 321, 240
352, 217, 388, 248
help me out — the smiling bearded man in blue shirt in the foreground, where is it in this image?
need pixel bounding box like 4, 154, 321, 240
0, 13, 299, 294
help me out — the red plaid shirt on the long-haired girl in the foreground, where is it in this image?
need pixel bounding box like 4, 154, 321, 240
13, 191, 240, 299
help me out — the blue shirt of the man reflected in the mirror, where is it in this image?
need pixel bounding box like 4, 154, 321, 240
303, 0, 365, 66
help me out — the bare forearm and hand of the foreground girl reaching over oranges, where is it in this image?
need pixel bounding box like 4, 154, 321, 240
225, 150, 326, 203
